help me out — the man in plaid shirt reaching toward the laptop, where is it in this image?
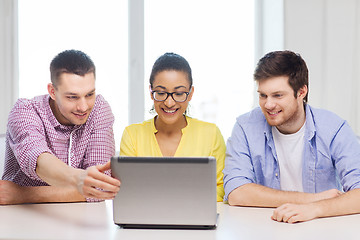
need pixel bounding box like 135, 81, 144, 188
0, 50, 120, 204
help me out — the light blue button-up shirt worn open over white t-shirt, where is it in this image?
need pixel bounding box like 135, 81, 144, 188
223, 105, 360, 201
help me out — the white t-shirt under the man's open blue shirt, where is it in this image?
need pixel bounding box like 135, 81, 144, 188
272, 123, 305, 192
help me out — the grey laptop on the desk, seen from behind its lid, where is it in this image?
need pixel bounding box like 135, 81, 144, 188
111, 156, 217, 229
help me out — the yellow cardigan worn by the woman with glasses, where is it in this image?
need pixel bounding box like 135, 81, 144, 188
120, 117, 226, 202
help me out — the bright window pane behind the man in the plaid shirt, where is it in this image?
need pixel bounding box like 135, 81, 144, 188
18, 0, 128, 150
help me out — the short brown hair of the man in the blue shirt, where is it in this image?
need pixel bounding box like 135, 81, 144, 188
254, 51, 309, 102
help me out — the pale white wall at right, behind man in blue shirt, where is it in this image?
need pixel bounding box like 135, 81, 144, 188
284, 0, 360, 135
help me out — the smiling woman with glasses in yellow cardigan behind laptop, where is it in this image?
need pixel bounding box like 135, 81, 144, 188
120, 53, 225, 201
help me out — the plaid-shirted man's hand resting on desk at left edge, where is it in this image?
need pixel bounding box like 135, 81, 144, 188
0, 180, 24, 205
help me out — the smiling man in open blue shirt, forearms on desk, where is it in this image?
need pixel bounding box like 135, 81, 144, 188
223, 51, 360, 223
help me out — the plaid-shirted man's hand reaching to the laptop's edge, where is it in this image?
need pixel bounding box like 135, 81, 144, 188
77, 161, 120, 200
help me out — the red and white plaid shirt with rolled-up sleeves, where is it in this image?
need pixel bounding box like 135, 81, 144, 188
2, 95, 115, 189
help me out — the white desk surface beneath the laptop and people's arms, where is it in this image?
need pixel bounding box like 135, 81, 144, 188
0, 201, 360, 240
